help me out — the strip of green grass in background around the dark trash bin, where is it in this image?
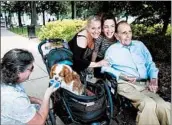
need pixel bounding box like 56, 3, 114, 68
9, 26, 41, 37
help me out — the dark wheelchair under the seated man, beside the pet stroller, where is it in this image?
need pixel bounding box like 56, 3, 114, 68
103, 72, 137, 125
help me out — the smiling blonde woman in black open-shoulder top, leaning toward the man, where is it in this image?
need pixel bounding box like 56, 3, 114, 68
69, 16, 108, 73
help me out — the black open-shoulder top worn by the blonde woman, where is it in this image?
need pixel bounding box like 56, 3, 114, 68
69, 34, 92, 73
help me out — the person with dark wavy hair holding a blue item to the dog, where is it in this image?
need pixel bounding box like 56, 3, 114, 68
0, 49, 57, 125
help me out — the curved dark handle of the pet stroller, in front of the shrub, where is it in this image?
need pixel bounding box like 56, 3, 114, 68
38, 38, 65, 57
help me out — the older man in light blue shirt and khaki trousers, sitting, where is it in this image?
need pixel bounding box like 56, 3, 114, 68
102, 21, 171, 125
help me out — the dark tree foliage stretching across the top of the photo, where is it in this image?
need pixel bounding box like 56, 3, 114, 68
2, 1, 171, 34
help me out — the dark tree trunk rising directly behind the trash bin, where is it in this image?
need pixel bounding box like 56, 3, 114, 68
31, 1, 37, 26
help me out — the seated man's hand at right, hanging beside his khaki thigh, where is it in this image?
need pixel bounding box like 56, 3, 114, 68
148, 78, 158, 93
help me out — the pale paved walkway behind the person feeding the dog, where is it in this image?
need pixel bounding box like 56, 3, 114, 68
1, 28, 63, 125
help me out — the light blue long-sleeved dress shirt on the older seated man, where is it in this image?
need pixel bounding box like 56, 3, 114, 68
102, 40, 159, 81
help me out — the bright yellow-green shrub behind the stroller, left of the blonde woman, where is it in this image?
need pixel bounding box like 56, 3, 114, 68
38, 19, 86, 41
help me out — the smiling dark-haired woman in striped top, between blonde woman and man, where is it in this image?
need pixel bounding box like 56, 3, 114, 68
90, 13, 116, 78
